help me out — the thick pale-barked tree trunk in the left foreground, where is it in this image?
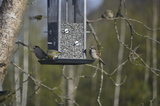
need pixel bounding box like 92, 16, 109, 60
0, 0, 27, 83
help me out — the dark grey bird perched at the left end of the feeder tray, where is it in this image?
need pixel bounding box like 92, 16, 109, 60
34, 46, 48, 60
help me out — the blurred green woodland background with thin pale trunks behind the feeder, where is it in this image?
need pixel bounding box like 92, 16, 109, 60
0, 0, 160, 106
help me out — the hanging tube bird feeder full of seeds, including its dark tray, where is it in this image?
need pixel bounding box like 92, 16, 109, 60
39, 0, 94, 65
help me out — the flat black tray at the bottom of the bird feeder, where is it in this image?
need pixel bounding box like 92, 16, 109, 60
38, 59, 95, 65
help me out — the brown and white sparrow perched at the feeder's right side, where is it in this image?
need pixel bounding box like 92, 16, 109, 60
89, 46, 105, 65
